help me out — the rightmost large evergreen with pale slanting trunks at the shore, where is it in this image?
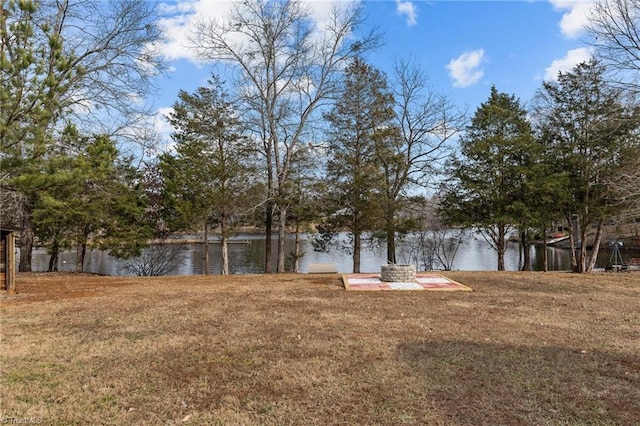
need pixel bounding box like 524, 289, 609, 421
538, 60, 640, 272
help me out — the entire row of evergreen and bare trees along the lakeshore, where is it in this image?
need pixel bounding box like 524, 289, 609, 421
0, 0, 640, 273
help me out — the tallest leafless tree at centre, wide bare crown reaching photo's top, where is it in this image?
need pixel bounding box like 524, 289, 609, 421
192, 0, 378, 272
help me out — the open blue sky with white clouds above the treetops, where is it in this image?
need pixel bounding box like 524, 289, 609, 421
149, 0, 592, 145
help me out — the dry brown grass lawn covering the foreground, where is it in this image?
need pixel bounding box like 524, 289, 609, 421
0, 272, 640, 425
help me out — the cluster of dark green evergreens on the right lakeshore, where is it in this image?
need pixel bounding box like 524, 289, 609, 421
441, 60, 640, 272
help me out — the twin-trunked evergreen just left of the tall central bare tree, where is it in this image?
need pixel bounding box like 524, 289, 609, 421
159, 77, 255, 274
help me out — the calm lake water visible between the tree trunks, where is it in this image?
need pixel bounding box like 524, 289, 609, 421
23, 234, 640, 275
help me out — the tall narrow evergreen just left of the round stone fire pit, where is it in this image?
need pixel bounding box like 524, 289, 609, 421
325, 58, 395, 272
